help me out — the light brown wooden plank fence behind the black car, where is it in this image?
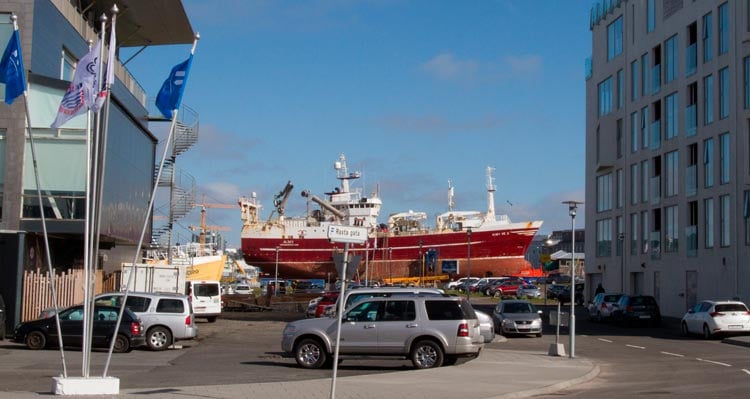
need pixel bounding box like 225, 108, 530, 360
21, 269, 104, 321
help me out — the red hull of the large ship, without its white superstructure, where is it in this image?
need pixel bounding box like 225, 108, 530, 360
242, 228, 537, 280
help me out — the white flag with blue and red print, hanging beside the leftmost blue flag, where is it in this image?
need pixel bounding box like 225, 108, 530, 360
51, 40, 102, 129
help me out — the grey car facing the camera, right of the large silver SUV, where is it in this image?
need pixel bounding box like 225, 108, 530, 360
492, 300, 542, 337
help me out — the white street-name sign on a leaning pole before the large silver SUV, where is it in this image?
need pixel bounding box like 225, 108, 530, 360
328, 224, 367, 399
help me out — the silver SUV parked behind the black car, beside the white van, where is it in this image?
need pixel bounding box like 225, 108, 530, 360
95, 292, 198, 351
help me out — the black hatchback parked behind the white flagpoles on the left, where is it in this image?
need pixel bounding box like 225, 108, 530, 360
14, 305, 146, 353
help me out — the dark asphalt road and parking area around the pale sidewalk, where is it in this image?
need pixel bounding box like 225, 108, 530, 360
0, 304, 750, 398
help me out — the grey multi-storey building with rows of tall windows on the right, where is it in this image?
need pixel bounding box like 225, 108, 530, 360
586, 0, 750, 316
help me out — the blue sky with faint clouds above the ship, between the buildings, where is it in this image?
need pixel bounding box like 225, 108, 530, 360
121, 0, 591, 246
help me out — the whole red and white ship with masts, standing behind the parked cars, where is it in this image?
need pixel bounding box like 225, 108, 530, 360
239, 154, 542, 281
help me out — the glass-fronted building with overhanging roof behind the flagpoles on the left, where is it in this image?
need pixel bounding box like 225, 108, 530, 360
0, 0, 195, 328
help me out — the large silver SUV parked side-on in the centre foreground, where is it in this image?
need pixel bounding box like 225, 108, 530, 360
281, 294, 484, 369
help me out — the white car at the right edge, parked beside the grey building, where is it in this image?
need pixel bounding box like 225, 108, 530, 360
680, 301, 750, 339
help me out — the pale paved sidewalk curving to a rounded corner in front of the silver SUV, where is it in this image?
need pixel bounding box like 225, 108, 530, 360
0, 349, 599, 399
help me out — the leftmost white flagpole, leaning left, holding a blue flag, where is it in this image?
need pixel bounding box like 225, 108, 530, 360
10, 14, 68, 377
